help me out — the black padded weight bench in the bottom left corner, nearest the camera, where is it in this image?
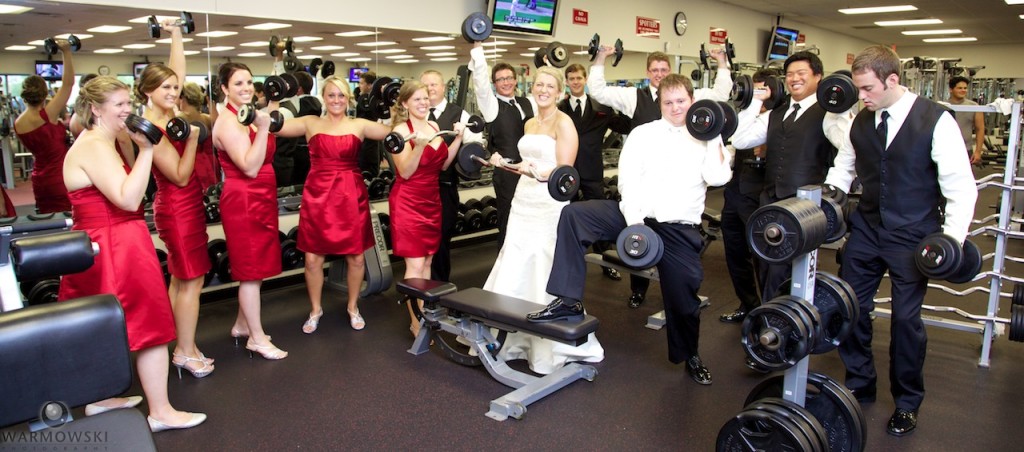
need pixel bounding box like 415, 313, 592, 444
0, 295, 157, 451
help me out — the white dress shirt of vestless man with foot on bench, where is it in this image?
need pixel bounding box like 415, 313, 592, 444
618, 119, 732, 224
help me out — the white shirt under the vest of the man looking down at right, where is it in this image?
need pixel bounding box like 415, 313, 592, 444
825, 88, 978, 243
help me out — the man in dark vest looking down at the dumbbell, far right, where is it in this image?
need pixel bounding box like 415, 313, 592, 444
825, 45, 978, 436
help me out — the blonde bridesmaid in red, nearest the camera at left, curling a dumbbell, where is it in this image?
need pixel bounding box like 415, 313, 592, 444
57, 77, 206, 432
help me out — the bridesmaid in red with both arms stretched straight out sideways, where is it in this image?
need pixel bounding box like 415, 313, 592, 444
278, 76, 391, 334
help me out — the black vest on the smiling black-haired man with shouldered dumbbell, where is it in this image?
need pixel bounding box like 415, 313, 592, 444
765, 104, 836, 199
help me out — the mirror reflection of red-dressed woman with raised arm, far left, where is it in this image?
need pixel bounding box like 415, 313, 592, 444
14, 39, 75, 213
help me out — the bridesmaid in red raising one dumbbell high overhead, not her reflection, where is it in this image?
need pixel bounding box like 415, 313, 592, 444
135, 19, 214, 378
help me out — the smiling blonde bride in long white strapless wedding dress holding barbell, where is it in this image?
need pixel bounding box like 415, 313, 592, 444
483, 67, 604, 374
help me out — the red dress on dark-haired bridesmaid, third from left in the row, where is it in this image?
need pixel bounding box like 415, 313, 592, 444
217, 105, 281, 281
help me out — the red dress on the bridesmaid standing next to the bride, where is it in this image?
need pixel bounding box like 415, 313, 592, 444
388, 122, 447, 257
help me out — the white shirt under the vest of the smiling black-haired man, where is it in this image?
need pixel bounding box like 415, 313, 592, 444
729, 93, 857, 149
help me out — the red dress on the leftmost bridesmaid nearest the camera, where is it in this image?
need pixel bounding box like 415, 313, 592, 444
57, 182, 175, 352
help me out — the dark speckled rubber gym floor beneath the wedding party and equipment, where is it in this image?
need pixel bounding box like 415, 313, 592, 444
146, 175, 1024, 451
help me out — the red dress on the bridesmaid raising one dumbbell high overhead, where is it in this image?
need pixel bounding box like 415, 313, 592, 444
153, 127, 211, 280
